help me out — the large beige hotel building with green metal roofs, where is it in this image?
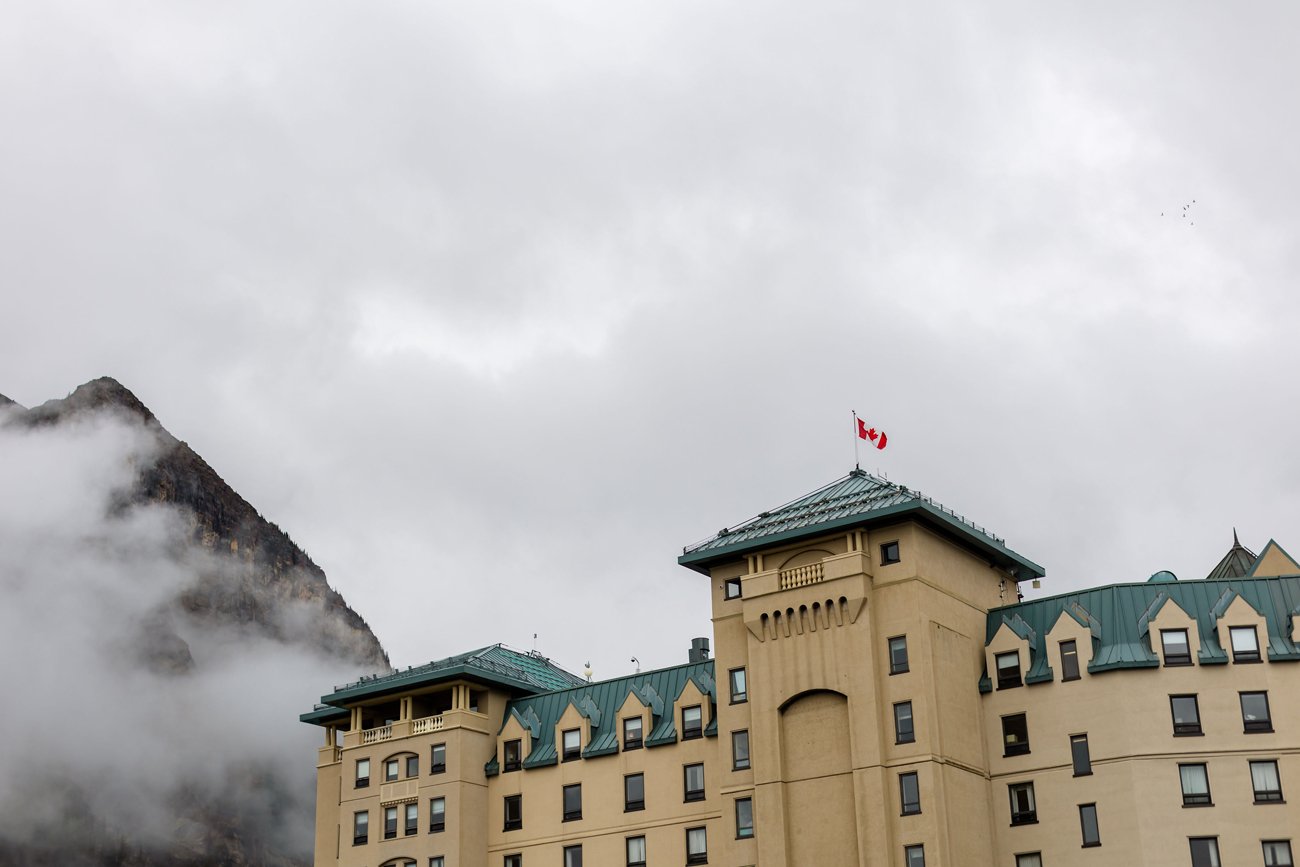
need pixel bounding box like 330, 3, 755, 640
302, 471, 1300, 867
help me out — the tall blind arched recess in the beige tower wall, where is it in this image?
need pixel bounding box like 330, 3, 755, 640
780, 689, 858, 864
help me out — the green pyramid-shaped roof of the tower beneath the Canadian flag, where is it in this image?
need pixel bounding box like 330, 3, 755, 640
677, 469, 1044, 578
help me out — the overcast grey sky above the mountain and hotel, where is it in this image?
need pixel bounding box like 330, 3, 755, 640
0, 0, 1300, 675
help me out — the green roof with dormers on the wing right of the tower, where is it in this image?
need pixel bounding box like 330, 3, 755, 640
980, 576, 1300, 693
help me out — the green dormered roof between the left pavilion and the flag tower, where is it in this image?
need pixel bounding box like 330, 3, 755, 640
486, 659, 718, 776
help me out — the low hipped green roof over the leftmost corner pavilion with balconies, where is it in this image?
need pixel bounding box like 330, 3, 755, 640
299, 645, 586, 724
